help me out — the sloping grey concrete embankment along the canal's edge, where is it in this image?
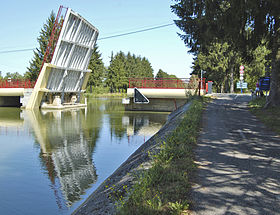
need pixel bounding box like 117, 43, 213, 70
73, 103, 190, 215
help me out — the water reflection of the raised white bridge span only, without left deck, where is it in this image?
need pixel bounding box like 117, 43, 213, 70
30, 107, 101, 207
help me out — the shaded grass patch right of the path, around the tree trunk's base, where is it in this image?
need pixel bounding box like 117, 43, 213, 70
249, 97, 280, 134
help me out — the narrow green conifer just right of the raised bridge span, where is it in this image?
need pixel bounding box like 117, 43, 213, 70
88, 45, 105, 87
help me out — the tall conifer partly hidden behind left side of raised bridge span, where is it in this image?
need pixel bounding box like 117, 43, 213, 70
24, 11, 56, 81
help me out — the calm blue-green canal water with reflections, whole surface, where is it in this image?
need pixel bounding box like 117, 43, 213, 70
0, 98, 167, 215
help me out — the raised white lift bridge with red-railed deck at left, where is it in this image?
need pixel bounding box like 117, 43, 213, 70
0, 6, 98, 109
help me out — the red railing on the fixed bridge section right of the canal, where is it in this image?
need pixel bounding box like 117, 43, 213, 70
129, 78, 205, 89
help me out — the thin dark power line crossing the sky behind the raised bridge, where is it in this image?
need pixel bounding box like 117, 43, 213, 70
0, 23, 175, 54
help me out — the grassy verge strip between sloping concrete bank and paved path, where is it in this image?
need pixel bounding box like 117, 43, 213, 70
118, 99, 206, 215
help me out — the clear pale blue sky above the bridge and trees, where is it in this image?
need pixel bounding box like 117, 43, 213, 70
0, 0, 193, 78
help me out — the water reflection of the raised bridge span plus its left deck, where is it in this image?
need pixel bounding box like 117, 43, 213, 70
0, 108, 97, 208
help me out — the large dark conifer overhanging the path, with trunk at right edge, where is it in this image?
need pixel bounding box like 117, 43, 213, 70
171, 0, 280, 106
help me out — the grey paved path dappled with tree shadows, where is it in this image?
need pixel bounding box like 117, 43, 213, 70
192, 94, 280, 215
